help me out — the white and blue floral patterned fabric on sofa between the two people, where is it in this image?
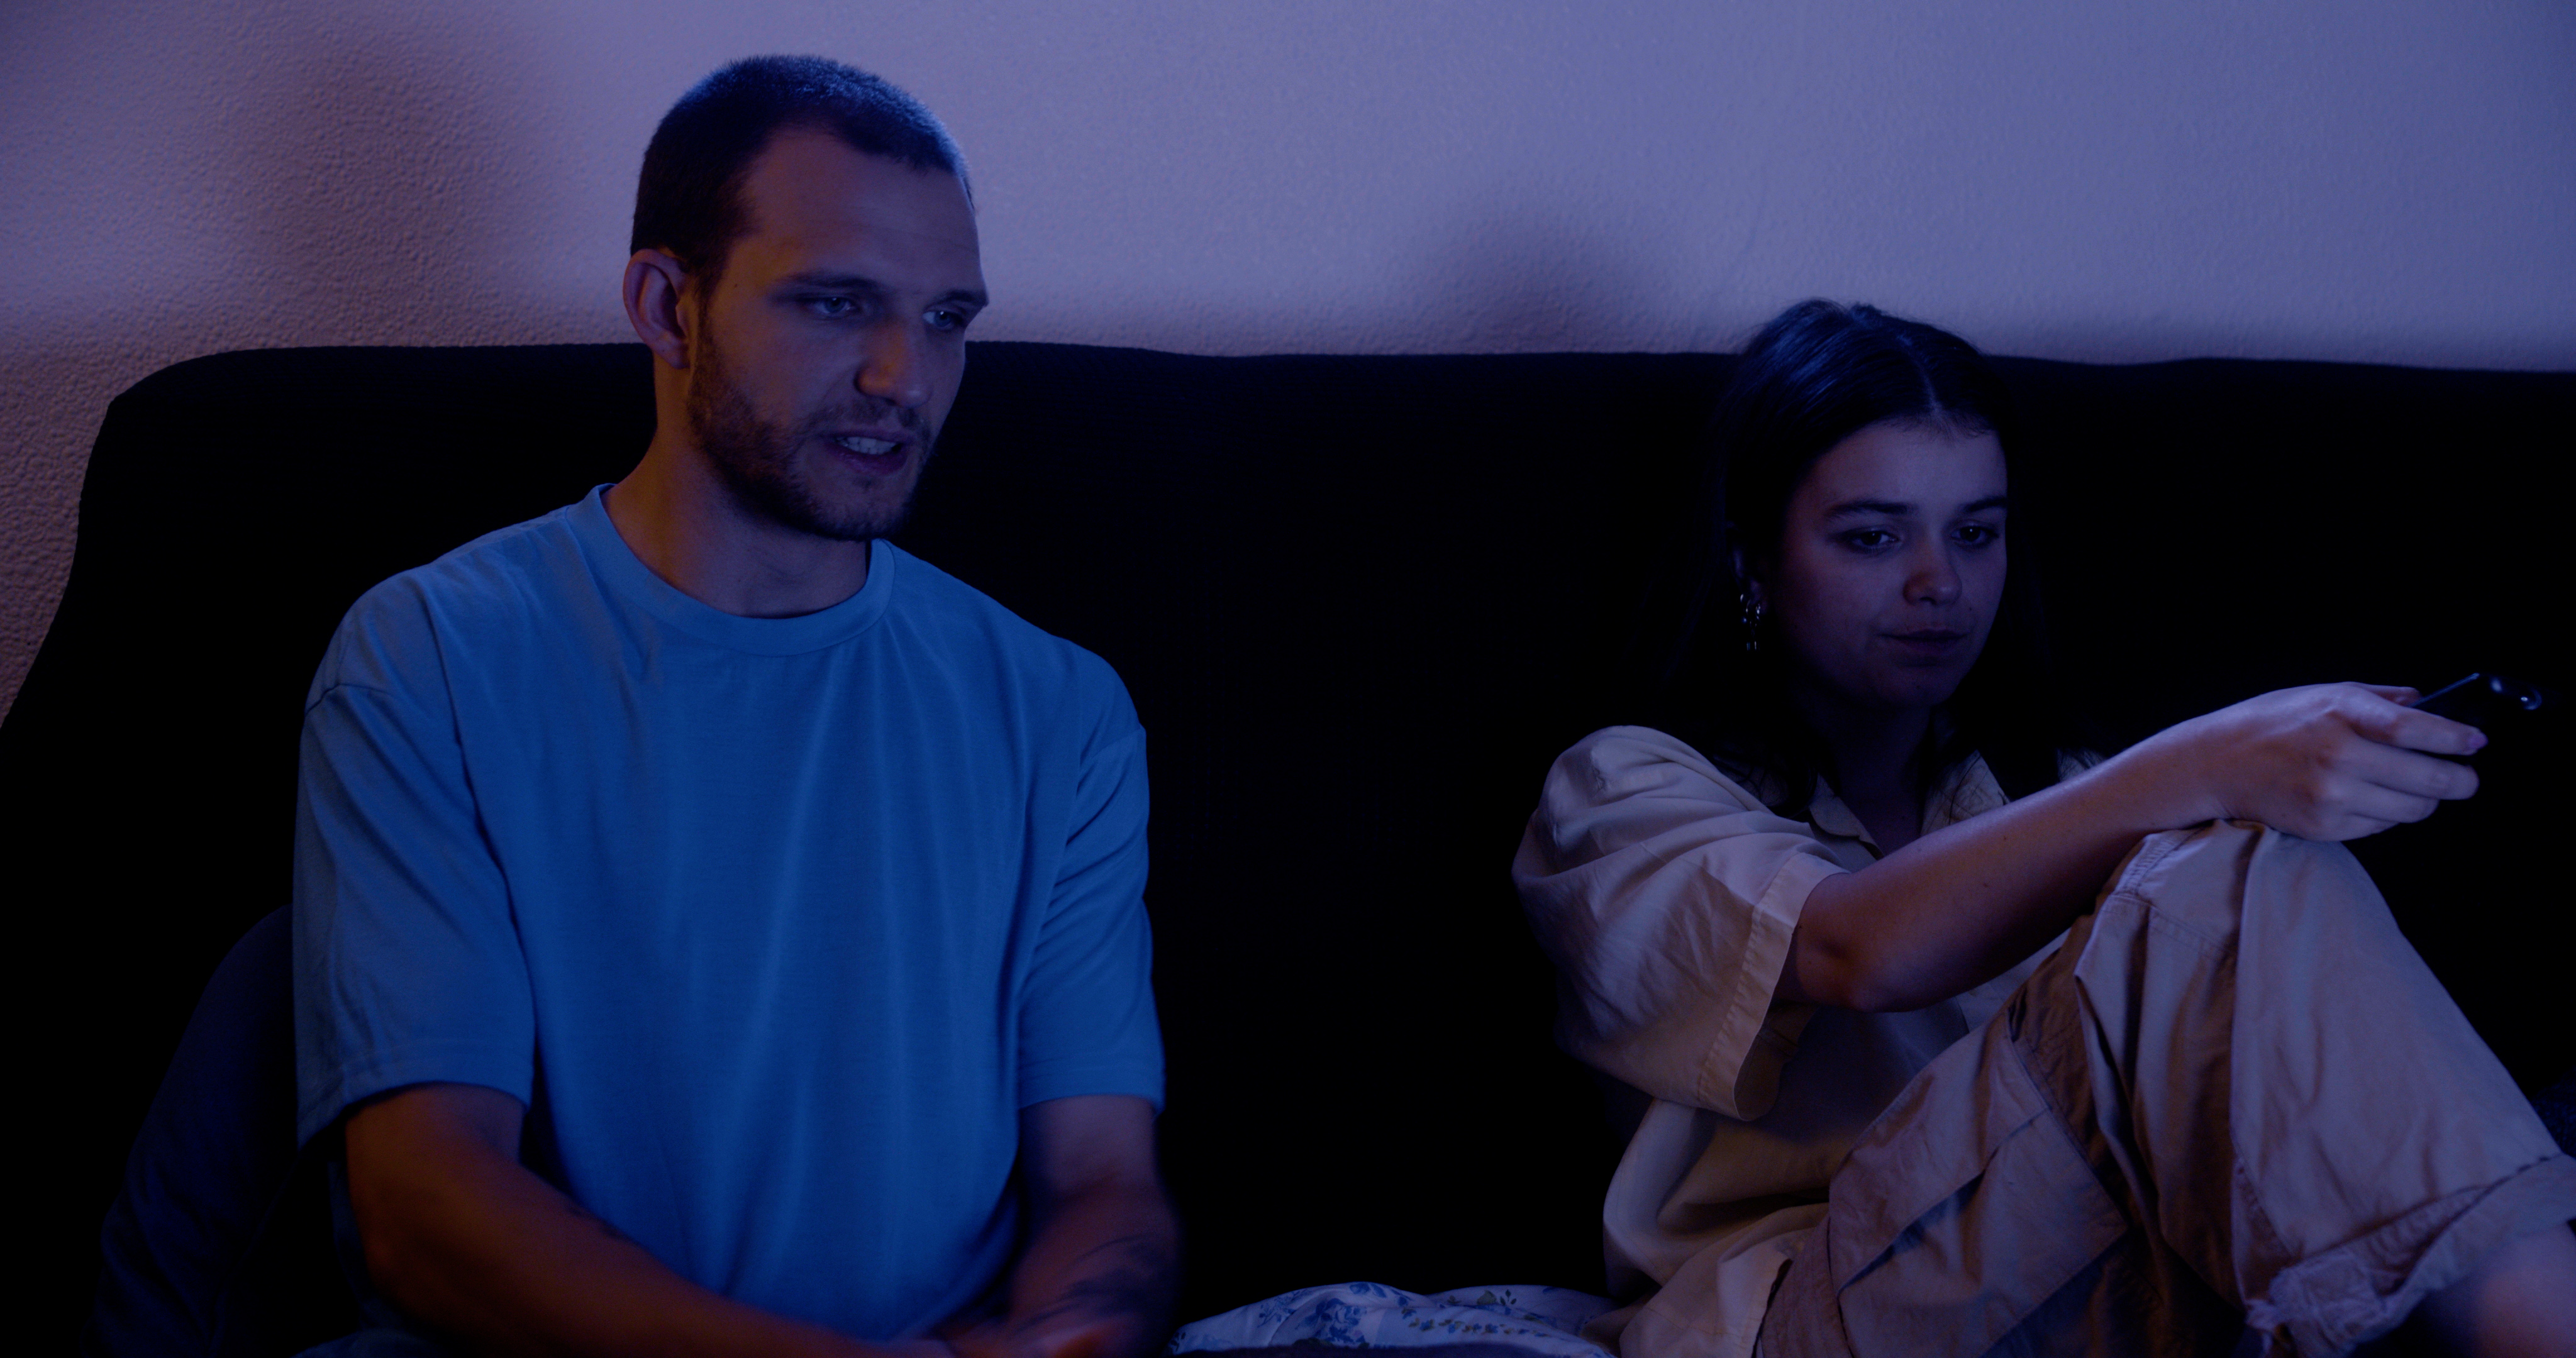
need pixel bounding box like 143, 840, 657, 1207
1170, 1283, 1613, 1358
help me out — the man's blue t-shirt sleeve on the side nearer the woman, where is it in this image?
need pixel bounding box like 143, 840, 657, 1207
1020, 668, 1162, 1108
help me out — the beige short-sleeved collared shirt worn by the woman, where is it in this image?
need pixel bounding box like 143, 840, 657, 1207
1512, 727, 2045, 1358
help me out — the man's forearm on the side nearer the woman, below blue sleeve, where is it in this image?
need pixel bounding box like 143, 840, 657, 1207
948, 1095, 1180, 1358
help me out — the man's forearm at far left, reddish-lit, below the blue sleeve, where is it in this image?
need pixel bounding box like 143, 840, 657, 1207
348, 1085, 886, 1358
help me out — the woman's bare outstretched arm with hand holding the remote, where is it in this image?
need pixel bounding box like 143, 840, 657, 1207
1777, 683, 2486, 1010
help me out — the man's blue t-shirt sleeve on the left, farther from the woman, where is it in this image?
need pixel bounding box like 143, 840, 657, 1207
294, 600, 536, 1139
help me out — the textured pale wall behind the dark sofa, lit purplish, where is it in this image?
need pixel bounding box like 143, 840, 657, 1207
0, 0, 2576, 721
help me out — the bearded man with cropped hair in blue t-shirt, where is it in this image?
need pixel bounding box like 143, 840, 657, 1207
296, 57, 1175, 1358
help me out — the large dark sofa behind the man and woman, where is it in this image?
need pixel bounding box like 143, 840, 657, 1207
0, 343, 2576, 1350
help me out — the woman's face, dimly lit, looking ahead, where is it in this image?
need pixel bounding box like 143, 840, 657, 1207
1752, 420, 2004, 714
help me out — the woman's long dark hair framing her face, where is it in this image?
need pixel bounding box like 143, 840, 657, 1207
1631, 302, 2076, 817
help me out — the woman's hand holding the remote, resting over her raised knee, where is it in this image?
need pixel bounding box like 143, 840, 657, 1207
2128, 683, 2486, 840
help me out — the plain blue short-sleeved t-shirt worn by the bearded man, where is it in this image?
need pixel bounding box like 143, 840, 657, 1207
296, 490, 1162, 1340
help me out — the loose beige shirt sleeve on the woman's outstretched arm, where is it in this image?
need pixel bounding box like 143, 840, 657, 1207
1512, 727, 1845, 1118
